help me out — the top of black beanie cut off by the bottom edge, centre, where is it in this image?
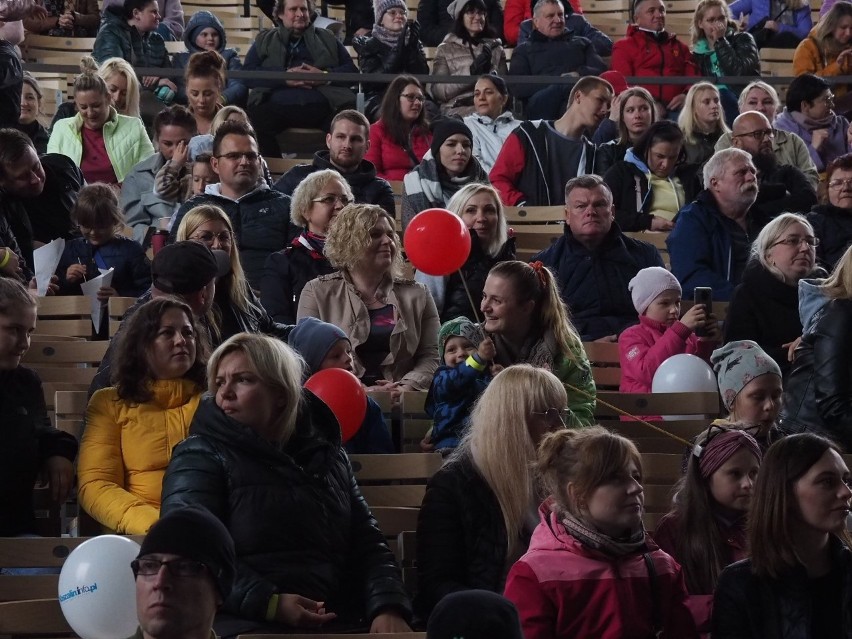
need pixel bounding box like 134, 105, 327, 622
426, 590, 524, 639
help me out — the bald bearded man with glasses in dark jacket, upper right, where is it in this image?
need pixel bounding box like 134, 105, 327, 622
731, 111, 817, 217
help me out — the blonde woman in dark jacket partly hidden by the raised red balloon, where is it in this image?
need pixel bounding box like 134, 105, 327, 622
414, 182, 515, 322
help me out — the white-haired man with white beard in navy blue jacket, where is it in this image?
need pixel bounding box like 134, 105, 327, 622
666, 149, 769, 301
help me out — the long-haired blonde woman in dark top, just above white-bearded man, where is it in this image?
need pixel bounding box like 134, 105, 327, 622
677, 82, 730, 166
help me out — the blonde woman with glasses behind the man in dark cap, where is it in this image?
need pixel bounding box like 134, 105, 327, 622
177, 204, 289, 344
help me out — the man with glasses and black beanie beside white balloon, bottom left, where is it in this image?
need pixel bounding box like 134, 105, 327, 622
125, 507, 236, 639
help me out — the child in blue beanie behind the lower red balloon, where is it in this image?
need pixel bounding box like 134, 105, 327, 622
287, 317, 396, 454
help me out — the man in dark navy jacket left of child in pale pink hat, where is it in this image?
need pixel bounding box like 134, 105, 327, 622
533, 175, 663, 342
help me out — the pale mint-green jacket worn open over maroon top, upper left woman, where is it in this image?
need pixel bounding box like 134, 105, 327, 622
47, 107, 154, 182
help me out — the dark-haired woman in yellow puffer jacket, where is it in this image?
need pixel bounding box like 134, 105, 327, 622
77, 298, 208, 535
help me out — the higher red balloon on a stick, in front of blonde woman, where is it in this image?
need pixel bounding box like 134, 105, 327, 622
403, 209, 470, 275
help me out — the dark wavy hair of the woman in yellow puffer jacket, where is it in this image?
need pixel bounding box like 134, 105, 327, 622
110, 297, 209, 404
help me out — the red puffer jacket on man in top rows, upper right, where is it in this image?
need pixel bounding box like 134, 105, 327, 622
611, 24, 701, 105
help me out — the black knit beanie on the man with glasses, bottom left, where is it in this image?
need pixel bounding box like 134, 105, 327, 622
137, 506, 237, 599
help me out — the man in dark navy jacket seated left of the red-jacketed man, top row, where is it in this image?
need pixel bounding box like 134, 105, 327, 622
509, 0, 606, 120
